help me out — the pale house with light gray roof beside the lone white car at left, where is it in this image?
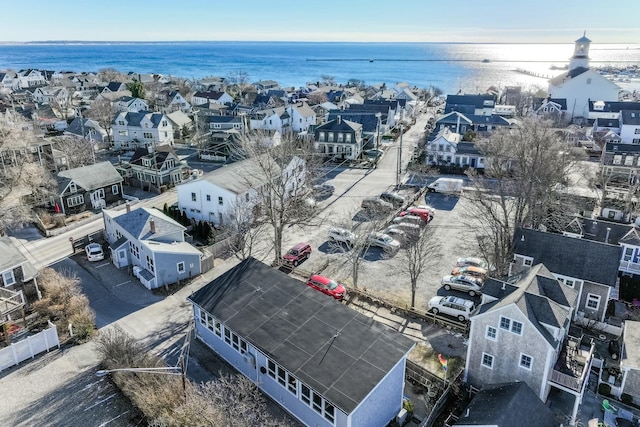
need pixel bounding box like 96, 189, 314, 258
102, 205, 202, 289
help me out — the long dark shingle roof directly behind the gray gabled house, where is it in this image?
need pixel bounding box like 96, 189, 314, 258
514, 228, 622, 286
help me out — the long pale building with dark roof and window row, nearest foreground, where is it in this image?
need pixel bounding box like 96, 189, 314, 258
188, 258, 415, 427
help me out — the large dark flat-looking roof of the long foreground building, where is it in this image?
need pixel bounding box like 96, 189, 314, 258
188, 258, 415, 414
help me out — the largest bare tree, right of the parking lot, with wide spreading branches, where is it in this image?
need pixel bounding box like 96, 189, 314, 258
465, 119, 584, 274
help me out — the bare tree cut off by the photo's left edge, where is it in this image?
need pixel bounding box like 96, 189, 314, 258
0, 112, 55, 235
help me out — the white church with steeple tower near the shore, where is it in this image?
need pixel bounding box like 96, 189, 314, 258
547, 36, 620, 118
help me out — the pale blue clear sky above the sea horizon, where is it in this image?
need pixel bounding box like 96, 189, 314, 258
0, 0, 640, 44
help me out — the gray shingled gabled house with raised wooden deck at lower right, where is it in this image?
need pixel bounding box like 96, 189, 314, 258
465, 264, 594, 426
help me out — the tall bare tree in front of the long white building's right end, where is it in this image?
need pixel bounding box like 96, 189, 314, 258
239, 134, 319, 262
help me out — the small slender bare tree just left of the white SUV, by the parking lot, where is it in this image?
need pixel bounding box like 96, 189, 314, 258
398, 226, 442, 308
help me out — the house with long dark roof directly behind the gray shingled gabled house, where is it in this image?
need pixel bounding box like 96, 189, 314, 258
512, 228, 622, 322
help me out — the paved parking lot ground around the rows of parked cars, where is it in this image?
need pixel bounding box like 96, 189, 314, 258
285, 170, 477, 310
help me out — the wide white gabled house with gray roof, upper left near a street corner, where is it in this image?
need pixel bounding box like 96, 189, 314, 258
111, 111, 173, 150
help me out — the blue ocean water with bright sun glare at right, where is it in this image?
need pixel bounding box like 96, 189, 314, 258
0, 42, 640, 93
